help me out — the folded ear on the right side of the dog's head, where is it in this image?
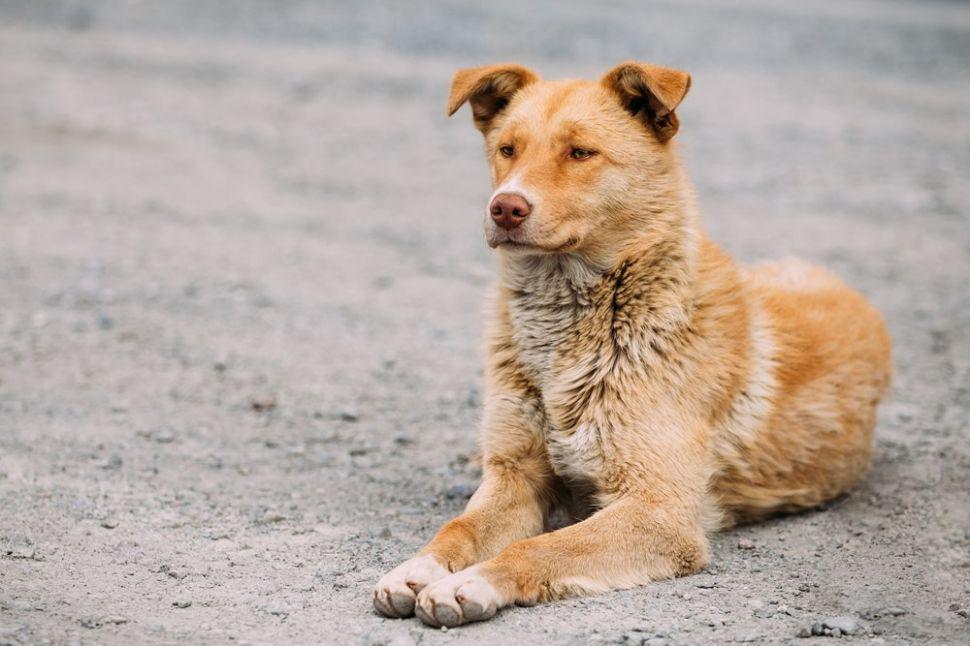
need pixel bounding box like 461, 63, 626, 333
600, 61, 690, 143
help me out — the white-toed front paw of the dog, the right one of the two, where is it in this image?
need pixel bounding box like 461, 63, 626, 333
414, 566, 505, 628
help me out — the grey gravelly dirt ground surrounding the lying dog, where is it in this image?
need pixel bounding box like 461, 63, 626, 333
0, 0, 970, 646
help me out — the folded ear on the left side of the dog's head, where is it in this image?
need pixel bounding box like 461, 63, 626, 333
448, 64, 539, 134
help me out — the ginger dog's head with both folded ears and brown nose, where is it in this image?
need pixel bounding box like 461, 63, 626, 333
448, 63, 690, 262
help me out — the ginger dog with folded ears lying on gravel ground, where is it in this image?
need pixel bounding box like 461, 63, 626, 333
373, 62, 892, 627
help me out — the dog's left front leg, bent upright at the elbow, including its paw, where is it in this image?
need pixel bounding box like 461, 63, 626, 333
374, 390, 553, 617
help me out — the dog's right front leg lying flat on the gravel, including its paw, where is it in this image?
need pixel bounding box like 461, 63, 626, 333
415, 494, 707, 626
